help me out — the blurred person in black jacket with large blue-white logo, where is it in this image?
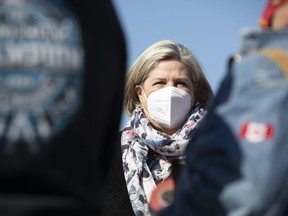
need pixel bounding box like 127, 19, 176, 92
0, 0, 126, 216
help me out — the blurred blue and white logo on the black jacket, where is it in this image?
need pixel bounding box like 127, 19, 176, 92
0, 0, 83, 152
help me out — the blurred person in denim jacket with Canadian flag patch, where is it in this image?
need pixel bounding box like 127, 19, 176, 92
159, 0, 288, 216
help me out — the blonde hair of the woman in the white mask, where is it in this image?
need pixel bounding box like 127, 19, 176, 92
123, 40, 213, 116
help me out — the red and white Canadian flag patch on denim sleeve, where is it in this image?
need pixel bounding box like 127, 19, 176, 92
240, 122, 274, 143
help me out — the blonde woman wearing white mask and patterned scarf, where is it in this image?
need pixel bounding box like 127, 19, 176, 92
104, 40, 213, 215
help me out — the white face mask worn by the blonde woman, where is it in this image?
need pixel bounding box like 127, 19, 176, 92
142, 86, 192, 129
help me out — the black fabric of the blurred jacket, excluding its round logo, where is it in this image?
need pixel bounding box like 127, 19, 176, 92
0, 0, 126, 216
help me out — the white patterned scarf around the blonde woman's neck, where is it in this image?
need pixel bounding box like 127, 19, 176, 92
121, 103, 206, 216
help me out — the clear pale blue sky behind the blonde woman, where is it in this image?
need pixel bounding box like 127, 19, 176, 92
113, 0, 267, 129
